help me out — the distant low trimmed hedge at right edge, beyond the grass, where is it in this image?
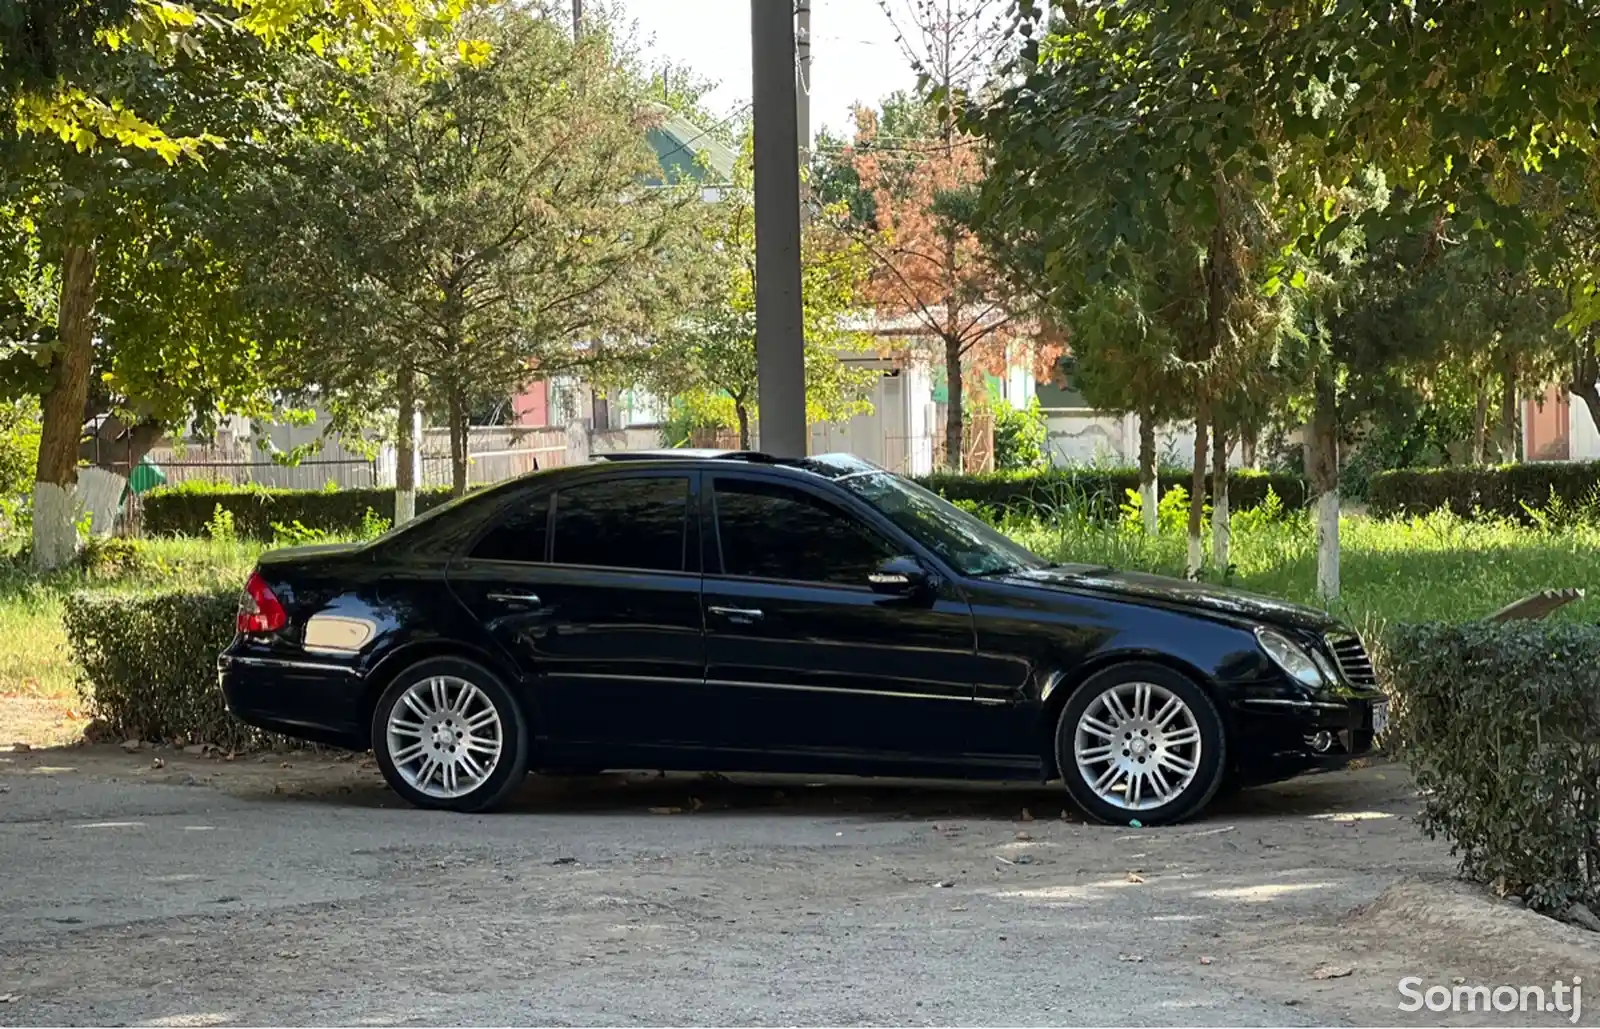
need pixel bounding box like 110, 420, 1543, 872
1366, 461, 1600, 520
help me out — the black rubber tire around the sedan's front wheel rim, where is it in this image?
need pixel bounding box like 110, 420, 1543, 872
1056, 663, 1227, 826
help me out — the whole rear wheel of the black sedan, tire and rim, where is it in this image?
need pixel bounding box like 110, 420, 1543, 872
373, 658, 528, 811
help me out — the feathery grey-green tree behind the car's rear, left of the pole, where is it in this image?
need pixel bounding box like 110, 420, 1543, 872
256, 8, 701, 491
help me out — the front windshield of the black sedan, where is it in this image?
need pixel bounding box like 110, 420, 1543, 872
838, 472, 1050, 575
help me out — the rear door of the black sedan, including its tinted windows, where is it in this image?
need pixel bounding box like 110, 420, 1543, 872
451, 472, 706, 760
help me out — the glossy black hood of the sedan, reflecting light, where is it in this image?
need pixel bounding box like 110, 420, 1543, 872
1003, 565, 1339, 632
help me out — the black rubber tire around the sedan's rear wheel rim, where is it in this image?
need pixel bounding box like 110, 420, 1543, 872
373, 658, 530, 813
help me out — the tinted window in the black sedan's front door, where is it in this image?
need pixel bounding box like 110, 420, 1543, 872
715, 478, 896, 587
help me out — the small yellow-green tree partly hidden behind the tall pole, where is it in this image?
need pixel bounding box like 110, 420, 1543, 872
638, 160, 878, 450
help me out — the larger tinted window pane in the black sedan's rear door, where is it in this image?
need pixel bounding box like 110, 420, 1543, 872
550, 477, 690, 571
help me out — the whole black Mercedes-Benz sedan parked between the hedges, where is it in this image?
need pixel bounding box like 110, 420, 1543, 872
219, 451, 1387, 824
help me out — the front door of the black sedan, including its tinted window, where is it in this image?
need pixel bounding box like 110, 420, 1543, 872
702, 472, 974, 767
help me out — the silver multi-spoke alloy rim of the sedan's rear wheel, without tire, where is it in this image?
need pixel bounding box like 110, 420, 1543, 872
387, 675, 506, 800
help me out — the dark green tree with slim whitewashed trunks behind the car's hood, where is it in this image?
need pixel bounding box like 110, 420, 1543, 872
966, 5, 1285, 575
